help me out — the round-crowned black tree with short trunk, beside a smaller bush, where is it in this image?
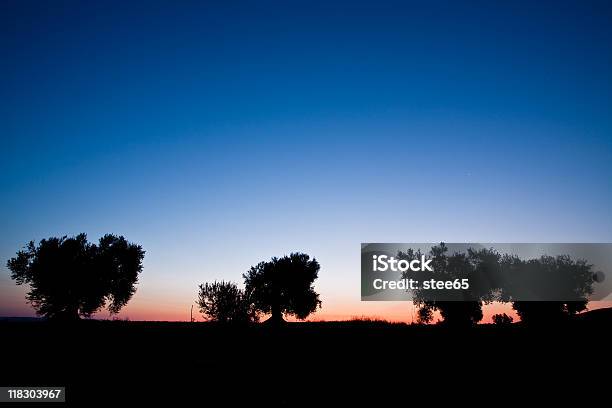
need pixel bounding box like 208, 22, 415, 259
243, 253, 321, 325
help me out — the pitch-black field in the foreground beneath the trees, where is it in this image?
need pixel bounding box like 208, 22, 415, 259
0, 311, 612, 407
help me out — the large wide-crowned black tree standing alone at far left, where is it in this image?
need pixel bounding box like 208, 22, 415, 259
7, 234, 145, 320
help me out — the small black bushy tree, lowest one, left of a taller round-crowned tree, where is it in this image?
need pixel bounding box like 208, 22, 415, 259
196, 281, 258, 323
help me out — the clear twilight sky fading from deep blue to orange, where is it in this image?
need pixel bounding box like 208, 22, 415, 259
0, 0, 612, 321
